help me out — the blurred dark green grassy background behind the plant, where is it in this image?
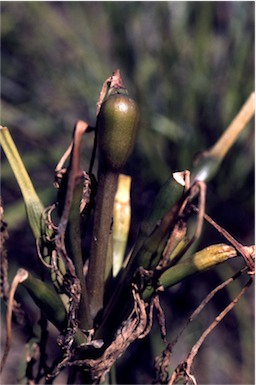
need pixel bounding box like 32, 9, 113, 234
1, 1, 255, 384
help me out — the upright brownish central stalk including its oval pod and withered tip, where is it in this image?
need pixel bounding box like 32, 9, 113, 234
87, 71, 138, 319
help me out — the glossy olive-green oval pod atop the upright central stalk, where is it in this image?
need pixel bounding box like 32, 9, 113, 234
97, 94, 139, 170
